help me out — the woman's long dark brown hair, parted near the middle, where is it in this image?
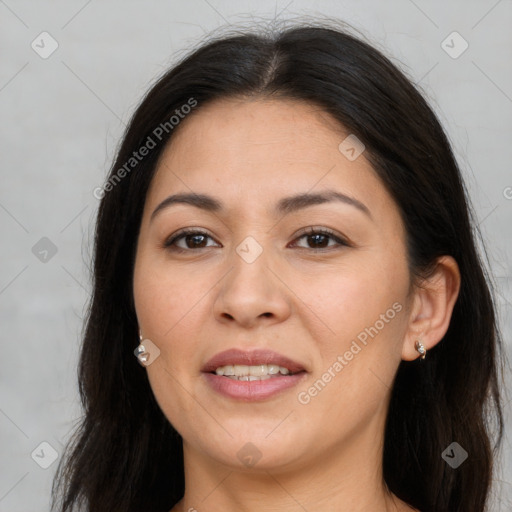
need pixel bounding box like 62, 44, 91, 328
52, 18, 503, 512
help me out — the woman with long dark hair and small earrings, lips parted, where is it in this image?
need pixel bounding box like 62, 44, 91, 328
54, 18, 502, 512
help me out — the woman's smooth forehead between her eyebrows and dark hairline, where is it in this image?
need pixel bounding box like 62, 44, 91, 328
147, 99, 391, 221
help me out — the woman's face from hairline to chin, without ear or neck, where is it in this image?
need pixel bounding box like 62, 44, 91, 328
133, 99, 416, 469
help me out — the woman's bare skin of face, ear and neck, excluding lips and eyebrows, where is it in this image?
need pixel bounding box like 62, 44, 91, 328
133, 98, 460, 512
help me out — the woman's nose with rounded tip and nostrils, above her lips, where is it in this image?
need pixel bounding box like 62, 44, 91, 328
213, 243, 291, 328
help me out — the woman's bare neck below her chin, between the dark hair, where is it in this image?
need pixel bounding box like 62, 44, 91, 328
173, 420, 412, 512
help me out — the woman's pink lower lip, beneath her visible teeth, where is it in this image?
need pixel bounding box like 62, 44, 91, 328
203, 372, 307, 402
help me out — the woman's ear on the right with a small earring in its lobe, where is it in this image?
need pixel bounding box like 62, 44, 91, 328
402, 256, 461, 361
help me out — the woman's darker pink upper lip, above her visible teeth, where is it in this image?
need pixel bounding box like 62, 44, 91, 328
201, 348, 305, 373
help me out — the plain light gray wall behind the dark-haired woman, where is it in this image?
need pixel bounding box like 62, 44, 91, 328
0, 0, 512, 512
